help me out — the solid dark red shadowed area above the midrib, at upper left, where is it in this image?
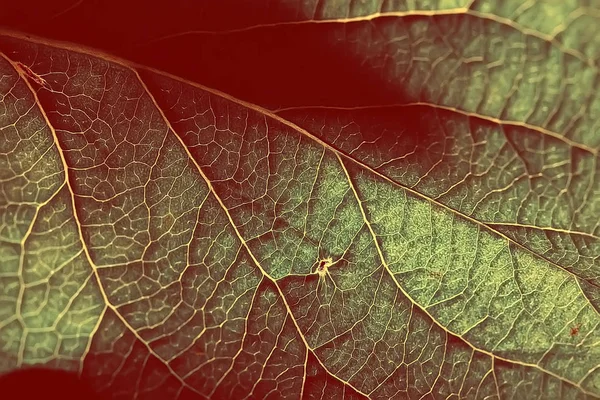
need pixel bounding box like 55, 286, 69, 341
0, 0, 418, 108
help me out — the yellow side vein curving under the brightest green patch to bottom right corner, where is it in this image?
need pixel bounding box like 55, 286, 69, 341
336, 153, 597, 396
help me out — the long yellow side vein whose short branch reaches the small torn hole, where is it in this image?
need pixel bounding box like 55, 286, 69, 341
131, 68, 368, 397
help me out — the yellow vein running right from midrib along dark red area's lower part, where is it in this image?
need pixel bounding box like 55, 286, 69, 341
272, 101, 598, 156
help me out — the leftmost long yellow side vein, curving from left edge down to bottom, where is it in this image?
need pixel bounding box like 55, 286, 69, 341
0, 53, 201, 394
